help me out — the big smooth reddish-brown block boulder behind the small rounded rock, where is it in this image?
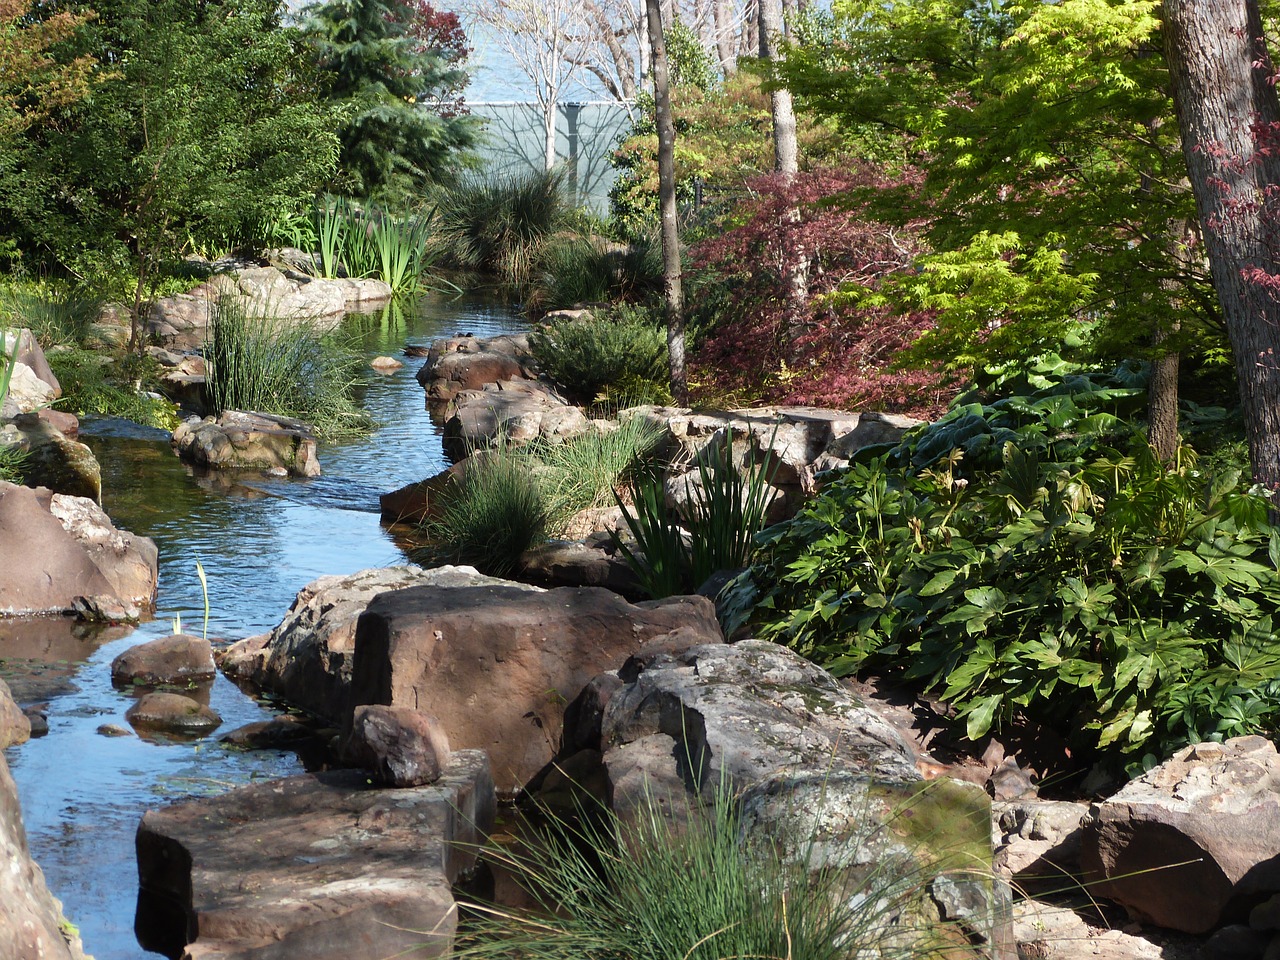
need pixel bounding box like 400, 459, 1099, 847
352, 584, 721, 791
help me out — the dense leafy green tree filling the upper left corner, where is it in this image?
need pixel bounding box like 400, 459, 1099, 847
0, 0, 337, 289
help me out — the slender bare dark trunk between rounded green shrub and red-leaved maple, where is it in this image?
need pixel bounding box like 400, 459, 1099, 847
645, 0, 689, 403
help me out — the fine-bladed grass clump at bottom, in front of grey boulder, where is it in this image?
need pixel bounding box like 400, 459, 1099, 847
454, 787, 946, 960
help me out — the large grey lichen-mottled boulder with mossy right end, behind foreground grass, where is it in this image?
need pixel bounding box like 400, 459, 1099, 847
539, 640, 1006, 955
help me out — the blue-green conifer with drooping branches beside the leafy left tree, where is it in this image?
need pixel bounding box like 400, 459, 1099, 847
305, 0, 476, 200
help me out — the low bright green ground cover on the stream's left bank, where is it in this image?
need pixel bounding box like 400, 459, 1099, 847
49, 349, 178, 430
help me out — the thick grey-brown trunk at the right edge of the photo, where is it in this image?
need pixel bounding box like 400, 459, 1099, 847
1164, 0, 1280, 489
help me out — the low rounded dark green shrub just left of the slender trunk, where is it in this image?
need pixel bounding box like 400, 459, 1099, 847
529, 307, 668, 403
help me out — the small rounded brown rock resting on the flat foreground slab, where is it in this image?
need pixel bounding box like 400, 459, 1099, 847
343, 704, 449, 787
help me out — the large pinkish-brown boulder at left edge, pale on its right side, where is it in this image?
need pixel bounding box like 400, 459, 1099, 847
0, 483, 157, 614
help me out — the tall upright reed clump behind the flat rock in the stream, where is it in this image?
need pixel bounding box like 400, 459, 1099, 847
205, 298, 372, 438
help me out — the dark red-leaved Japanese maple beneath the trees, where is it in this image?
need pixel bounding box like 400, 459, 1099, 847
691, 166, 955, 417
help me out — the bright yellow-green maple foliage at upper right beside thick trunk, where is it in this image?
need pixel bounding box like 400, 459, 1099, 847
780, 0, 1221, 381
